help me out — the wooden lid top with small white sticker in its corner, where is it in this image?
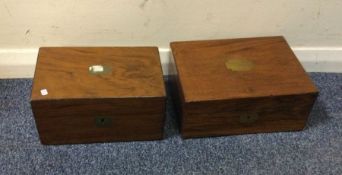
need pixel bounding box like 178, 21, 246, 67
31, 47, 165, 100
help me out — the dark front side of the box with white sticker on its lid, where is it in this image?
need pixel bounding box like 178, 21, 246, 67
31, 97, 165, 144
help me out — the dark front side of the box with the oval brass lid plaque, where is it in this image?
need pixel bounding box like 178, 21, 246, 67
182, 93, 317, 138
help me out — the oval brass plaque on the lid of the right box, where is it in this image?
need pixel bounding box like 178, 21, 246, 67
226, 58, 254, 72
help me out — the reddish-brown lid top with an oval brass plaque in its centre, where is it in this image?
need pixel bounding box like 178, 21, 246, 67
171, 37, 317, 102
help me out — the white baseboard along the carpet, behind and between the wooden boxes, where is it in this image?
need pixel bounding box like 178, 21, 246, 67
0, 47, 342, 79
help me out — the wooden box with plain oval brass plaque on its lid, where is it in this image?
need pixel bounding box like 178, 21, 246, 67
170, 37, 318, 138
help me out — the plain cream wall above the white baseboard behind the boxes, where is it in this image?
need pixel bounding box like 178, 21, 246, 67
0, 0, 342, 77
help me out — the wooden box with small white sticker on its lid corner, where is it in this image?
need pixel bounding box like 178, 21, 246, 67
31, 47, 166, 144
